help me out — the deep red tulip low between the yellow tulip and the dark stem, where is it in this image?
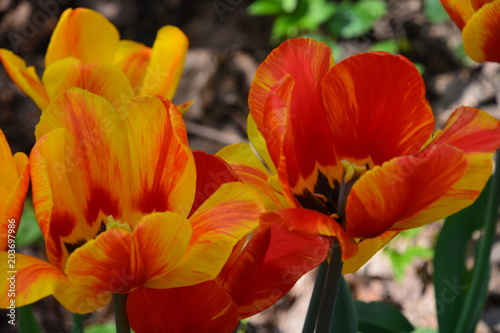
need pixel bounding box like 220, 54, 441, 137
127, 213, 330, 333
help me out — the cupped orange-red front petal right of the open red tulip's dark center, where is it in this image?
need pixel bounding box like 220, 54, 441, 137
346, 145, 467, 238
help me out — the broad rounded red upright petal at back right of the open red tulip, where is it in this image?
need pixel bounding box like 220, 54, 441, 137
323, 52, 434, 167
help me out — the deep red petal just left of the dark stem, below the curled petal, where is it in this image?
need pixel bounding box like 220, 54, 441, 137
218, 224, 330, 318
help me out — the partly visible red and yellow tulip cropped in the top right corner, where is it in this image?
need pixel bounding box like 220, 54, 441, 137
441, 0, 500, 62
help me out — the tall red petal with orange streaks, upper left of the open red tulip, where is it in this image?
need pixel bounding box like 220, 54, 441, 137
249, 38, 336, 188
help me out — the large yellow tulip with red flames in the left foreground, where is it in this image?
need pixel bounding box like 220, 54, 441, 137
0, 88, 263, 313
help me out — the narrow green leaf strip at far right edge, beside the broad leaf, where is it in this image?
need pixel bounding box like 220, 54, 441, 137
456, 150, 500, 333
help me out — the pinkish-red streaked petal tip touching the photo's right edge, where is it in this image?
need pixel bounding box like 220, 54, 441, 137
429, 106, 500, 153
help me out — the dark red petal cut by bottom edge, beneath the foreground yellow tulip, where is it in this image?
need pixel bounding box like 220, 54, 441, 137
127, 281, 239, 333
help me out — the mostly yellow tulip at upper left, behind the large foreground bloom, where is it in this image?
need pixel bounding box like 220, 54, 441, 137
0, 8, 188, 110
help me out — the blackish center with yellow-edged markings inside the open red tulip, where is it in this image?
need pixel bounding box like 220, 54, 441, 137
295, 160, 368, 228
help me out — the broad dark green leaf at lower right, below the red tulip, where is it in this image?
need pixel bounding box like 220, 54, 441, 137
434, 171, 500, 333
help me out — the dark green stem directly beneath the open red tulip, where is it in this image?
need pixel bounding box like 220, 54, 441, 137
316, 239, 342, 333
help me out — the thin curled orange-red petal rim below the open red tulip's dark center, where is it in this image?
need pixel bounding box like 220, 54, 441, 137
272, 208, 357, 260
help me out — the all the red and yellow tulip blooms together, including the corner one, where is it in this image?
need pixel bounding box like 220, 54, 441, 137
0, 0, 500, 333
